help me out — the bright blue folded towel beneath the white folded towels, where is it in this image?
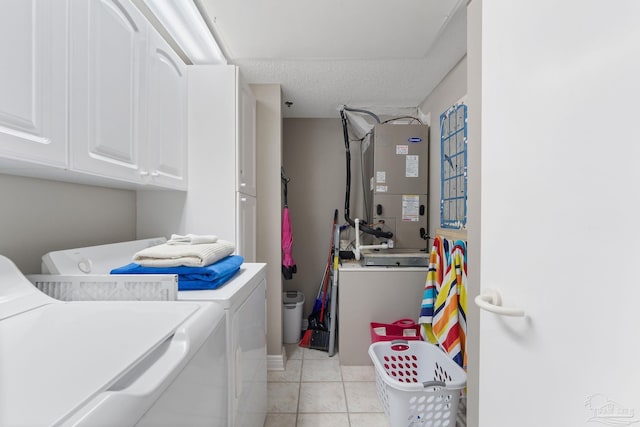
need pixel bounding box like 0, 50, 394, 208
111, 255, 244, 291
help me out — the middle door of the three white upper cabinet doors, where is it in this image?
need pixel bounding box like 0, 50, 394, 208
70, 0, 148, 182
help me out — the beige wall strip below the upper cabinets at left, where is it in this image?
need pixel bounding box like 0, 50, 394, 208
0, 175, 136, 274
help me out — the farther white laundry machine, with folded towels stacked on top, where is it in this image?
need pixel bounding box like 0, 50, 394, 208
37, 241, 267, 427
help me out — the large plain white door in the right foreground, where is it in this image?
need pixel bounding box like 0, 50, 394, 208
470, 0, 640, 427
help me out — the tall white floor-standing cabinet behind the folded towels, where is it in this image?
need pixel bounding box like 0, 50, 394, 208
137, 65, 257, 262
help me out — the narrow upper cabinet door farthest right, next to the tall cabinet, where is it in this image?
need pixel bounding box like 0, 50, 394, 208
145, 30, 187, 190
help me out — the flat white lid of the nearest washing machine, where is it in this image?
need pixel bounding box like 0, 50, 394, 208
0, 301, 202, 426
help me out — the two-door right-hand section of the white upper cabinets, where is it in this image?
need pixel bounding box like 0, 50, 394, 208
70, 0, 187, 190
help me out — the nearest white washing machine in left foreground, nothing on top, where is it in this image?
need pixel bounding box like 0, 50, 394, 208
0, 256, 229, 427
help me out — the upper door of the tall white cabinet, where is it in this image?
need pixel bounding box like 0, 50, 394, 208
236, 76, 256, 196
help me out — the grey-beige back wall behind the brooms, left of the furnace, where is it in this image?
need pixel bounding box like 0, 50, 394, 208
282, 118, 348, 318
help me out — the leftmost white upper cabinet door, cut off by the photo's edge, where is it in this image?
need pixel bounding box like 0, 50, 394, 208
0, 0, 67, 167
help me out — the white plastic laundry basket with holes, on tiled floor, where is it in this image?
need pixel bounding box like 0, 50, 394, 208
369, 340, 467, 427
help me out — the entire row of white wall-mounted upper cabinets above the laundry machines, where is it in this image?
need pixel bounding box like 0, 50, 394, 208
0, 0, 187, 190
